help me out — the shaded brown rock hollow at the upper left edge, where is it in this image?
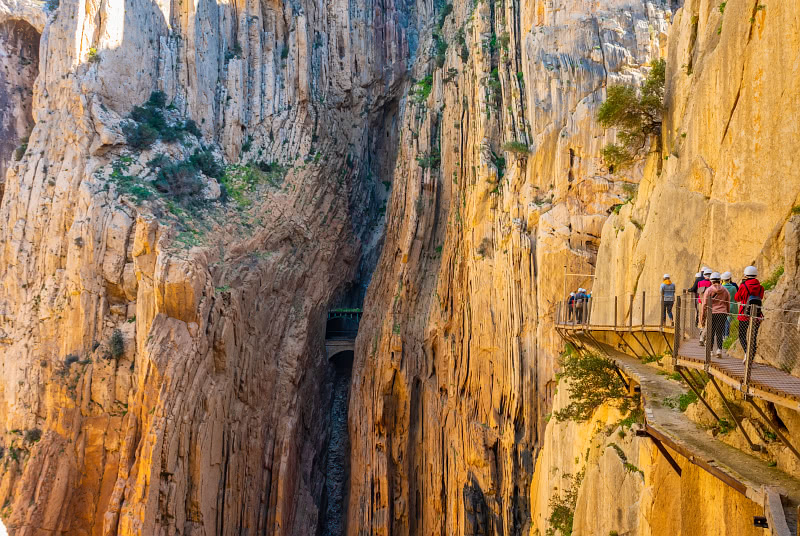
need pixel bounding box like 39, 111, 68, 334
0, 20, 40, 199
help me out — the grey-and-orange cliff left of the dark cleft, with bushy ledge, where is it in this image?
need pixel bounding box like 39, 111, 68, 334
0, 0, 416, 535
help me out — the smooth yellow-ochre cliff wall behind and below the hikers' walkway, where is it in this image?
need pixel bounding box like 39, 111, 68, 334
532, 0, 800, 535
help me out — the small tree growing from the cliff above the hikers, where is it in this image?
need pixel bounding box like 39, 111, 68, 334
597, 59, 666, 173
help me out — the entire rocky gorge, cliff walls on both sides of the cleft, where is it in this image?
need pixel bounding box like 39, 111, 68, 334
0, 0, 800, 536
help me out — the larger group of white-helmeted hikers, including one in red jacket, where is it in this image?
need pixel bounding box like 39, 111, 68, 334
661, 266, 764, 360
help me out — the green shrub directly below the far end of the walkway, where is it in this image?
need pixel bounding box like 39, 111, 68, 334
553, 349, 632, 422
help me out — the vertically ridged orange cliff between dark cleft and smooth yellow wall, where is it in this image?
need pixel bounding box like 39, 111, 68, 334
348, 1, 671, 534
